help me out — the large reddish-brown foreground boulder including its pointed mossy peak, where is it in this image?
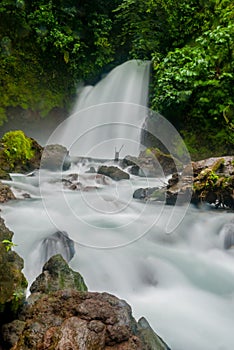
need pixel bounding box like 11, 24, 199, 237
3, 256, 170, 350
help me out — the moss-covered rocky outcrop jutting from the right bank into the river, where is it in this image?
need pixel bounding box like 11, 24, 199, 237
133, 157, 234, 209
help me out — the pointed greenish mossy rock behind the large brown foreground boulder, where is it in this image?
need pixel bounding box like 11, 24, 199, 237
30, 254, 87, 294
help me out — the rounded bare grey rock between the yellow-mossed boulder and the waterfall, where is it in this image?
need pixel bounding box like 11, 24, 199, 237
41, 145, 71, 171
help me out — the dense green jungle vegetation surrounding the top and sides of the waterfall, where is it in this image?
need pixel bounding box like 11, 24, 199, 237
0, 0, 234, 158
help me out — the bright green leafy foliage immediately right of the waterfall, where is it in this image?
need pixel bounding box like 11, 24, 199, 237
152, 17, 234, 157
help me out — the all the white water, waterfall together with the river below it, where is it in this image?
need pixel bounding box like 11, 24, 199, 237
1, 61, 234, 350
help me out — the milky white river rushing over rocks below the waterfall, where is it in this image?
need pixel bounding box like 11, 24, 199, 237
2, 60, 234, 350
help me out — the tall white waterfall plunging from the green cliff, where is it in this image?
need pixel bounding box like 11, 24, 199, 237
48, 60, 150, 159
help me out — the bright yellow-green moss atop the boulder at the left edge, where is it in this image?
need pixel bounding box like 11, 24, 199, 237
1, 130, 34, 168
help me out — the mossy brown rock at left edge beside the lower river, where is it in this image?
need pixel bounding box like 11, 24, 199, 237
0, 218, 27, 314
